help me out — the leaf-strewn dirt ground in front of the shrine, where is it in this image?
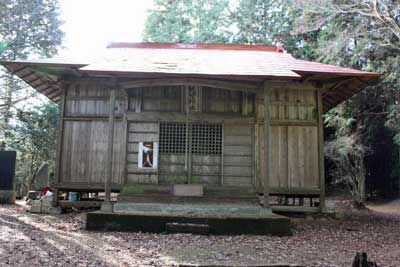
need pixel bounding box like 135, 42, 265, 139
0, 201, 400, 267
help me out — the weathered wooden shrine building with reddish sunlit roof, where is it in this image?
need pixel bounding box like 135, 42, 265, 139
1, 43, 380, 233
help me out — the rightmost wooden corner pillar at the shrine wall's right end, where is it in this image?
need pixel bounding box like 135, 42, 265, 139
317, 90, 325, 211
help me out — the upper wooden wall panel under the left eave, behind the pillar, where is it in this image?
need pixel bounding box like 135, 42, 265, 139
65, 81, 126, 117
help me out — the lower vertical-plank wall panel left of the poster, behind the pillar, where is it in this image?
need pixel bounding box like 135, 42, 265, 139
60, 120, 125, 185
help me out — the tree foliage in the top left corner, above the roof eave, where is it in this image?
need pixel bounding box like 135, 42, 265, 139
0, 0, 63, 59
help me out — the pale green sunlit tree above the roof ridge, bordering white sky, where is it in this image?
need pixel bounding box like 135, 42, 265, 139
144, 0, 232, 43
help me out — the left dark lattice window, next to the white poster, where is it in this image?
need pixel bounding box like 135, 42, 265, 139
159, 123, 186, 154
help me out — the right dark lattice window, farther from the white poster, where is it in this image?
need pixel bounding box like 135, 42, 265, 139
191, 123, 222, 155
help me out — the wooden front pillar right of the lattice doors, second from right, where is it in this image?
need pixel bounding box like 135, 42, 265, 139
263, 82, 270, 208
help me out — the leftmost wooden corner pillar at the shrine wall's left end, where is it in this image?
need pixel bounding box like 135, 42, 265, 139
52, 84, 67, 206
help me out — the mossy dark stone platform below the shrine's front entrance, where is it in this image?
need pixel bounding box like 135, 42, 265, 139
86, 202, 291, 235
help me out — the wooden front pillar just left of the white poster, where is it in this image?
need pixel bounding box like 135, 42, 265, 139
104, 88, 115, 202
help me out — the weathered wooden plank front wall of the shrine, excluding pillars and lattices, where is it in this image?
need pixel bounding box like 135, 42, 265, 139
59, 78, 323, 200
